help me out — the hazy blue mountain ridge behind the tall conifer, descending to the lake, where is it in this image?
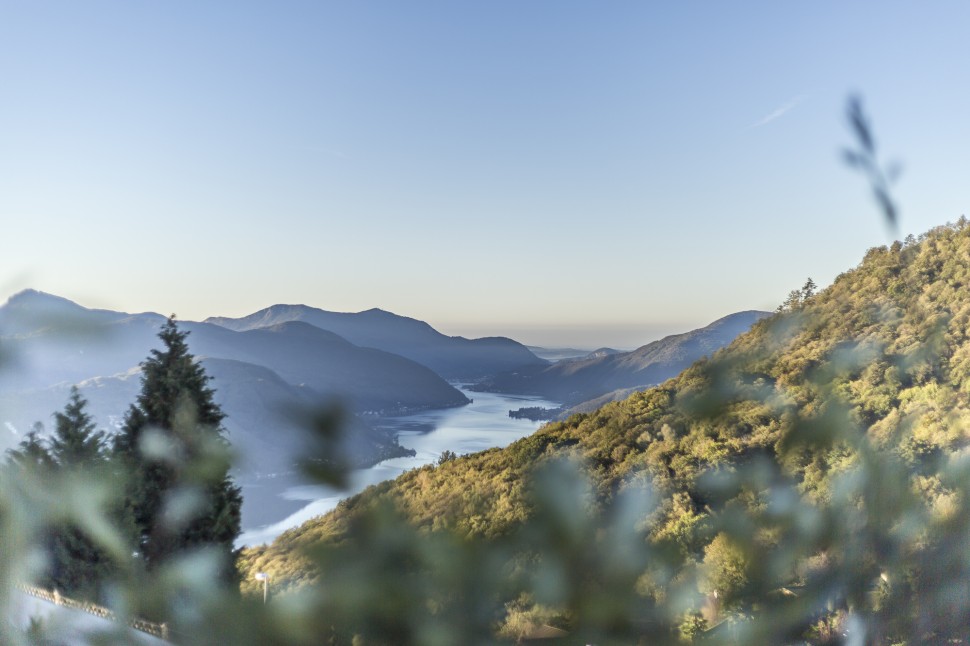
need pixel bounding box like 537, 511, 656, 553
0, 291, 467, 414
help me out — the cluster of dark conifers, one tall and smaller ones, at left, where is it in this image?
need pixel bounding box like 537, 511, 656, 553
7, 316, 242, 600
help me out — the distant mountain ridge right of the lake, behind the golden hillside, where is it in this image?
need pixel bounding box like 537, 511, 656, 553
471, 310, 769, 408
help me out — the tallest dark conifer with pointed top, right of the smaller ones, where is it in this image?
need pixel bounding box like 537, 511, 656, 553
113, 316, 242, 577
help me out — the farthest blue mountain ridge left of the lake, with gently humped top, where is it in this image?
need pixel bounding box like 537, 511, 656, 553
205, 305, 548, 380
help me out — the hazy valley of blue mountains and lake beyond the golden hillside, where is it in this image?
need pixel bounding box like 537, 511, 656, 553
0, 290, 760, 543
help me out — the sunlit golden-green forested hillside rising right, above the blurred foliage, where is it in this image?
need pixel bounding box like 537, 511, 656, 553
244, 220, 970, 630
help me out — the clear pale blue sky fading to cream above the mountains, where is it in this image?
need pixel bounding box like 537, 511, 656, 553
0, 0, 970, 348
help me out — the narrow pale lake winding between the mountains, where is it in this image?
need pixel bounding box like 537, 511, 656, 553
238, 389, 559, 545
